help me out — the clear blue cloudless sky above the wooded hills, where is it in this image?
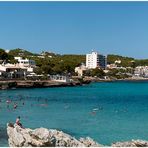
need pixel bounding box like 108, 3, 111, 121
0, 1, 148, 59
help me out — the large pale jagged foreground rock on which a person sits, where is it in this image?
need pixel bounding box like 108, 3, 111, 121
7, 123, 102, 147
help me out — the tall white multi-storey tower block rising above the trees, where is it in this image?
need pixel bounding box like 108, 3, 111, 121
86, 51, 107, 69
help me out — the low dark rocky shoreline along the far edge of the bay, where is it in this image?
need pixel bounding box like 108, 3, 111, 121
0, 77, 148, 90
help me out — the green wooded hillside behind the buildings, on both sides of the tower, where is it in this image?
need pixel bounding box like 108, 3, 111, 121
0, 48, 148, 74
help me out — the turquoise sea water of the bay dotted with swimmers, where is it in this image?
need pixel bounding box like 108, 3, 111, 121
0, 81, 148, 147
